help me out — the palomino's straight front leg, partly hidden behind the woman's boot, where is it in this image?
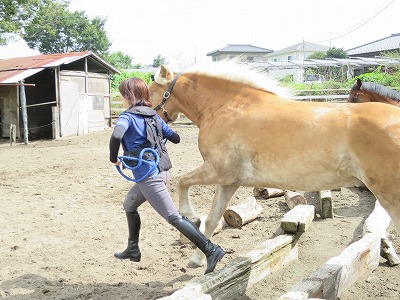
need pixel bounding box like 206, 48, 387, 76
189, 185, 238, 267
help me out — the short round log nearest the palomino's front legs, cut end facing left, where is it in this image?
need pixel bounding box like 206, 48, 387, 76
224, 197, 262, 228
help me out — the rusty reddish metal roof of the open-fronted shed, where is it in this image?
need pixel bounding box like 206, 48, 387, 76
0, 51, 120, 84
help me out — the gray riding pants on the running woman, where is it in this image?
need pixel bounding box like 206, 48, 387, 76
124, 171, 180, 222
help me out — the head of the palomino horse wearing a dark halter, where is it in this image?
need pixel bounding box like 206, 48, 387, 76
149, 65, 180, 122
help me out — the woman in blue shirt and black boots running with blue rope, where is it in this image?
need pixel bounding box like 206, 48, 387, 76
110, 78, 225, 274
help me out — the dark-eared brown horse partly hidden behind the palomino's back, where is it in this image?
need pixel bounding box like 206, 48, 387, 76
348, 79, 400, 107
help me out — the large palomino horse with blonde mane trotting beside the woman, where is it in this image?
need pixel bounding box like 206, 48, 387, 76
150, 62, 400, 265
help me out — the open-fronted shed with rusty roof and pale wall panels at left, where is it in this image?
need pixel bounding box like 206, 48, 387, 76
0, 51, 120, 142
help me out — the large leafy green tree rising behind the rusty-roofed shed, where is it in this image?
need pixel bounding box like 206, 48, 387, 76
23, 0, 111, 55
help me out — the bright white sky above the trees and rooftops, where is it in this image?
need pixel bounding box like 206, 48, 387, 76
0, 0, 400, 65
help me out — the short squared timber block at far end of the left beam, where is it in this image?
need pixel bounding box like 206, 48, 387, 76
281, 204, 315, 233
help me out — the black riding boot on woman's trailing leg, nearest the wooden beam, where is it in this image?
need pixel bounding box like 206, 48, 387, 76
171, 216, 225, 274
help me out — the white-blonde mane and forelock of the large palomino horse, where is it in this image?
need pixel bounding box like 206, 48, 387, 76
154, 61, 291, 98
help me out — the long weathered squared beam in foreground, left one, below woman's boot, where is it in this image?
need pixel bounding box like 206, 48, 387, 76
159, 234, 298, 300
